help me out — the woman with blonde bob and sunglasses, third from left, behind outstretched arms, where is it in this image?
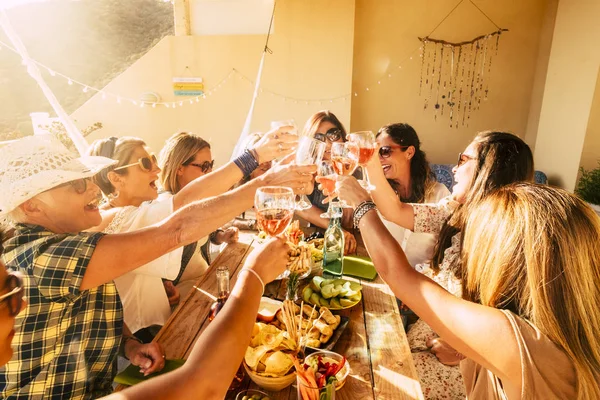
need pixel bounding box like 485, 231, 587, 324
159, 132, 238, 304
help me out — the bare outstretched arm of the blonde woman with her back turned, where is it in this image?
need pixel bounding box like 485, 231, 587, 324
339, 177, 521, 388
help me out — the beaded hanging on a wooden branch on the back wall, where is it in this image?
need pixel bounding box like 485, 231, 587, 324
419, 0, 508, 128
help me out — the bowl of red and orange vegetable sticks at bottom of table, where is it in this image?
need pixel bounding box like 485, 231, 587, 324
303, 350, 350, 390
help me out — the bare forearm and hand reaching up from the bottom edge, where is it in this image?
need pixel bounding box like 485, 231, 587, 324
102, 239, 288, 400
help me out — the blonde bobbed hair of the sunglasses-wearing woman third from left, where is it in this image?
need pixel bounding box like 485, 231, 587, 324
158, 132, 210, 194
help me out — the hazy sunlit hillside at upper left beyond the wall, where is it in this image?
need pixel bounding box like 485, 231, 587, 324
0, 0, 173, 140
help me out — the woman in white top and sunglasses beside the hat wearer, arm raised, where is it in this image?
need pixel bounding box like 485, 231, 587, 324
84, 127, 297, 342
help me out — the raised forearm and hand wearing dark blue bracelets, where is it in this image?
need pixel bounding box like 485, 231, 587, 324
173, 126, 298, 210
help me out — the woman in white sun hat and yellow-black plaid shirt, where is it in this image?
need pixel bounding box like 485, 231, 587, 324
0, 136, 314, 399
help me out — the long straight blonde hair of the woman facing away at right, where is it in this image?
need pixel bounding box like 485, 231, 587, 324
462, 183, 600, 400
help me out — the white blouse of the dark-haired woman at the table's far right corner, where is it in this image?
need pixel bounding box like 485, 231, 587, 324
381, 182, 450, 268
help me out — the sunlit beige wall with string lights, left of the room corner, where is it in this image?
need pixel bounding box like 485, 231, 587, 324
73, 0, 354, 164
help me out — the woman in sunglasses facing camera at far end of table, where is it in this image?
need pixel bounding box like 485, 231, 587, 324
296, 110, 356, 254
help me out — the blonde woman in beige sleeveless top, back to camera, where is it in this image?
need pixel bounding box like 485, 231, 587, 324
340, 182, 600, 400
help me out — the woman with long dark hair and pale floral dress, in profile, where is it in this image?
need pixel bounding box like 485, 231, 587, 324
328, 131, 534, 399
